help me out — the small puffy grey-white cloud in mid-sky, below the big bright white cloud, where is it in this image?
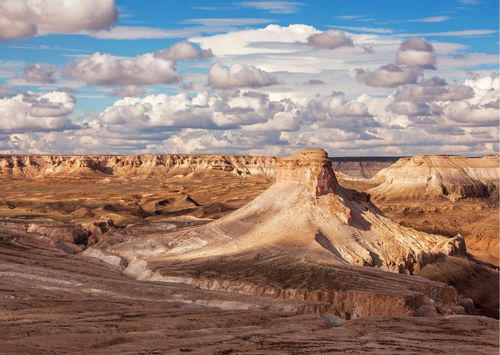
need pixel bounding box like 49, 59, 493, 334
208, 63, 278, 89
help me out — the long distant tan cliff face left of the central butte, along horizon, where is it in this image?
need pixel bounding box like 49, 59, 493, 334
0, 154, 276, 178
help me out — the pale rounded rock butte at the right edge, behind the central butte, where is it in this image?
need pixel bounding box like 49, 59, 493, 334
370, 155, 500, 201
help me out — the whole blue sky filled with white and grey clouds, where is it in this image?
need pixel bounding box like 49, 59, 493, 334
0, 0, 499, 156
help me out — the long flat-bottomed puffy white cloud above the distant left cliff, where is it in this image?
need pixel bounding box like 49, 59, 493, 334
98, 92, 295, 130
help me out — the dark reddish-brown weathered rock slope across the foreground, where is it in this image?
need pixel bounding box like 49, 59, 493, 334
0, 223, 498, 354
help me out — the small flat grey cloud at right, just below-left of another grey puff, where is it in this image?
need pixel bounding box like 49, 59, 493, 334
356, 64, 421, 87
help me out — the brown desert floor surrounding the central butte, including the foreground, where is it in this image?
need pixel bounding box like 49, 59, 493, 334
0, 157, 499, 354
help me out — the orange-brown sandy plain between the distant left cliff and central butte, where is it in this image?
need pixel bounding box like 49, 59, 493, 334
0, 170, 273, 226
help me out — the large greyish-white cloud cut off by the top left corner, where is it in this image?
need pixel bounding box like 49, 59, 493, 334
0, 0, 117, 39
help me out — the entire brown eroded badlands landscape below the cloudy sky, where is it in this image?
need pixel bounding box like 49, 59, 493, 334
0, 150, 500, 354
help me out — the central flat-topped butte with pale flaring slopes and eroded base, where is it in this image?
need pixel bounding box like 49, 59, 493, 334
85, 150, 465, 318
